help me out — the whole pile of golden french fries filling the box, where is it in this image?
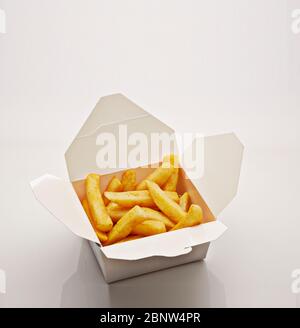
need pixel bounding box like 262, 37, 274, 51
82, 154, 203, 246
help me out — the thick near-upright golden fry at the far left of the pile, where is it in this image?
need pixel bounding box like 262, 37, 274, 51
85, 173, 113, 232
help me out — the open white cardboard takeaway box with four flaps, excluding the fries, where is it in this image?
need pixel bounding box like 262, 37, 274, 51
31, 94, 243, 282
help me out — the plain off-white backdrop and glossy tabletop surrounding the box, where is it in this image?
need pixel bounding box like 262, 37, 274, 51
0, 0, 300, 307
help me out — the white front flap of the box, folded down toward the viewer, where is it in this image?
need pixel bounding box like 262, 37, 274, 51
101, 221, 227, 260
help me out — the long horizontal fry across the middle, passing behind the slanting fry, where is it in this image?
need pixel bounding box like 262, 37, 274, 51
104, 190, 179, 207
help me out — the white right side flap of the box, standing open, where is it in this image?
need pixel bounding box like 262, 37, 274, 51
187, 133, 244, 216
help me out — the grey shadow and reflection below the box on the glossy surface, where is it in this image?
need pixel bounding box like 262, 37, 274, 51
60, 241, 226, 307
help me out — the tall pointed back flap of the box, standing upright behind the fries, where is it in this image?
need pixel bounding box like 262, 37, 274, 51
65, 94, 177, 181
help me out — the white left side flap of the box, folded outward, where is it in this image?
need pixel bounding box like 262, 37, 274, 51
31, 174, 99, 243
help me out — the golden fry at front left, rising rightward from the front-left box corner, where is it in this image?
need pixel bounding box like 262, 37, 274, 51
106, 206, 146, 245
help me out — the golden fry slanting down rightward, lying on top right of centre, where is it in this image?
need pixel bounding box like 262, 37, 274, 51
146, 180, 186, 223
